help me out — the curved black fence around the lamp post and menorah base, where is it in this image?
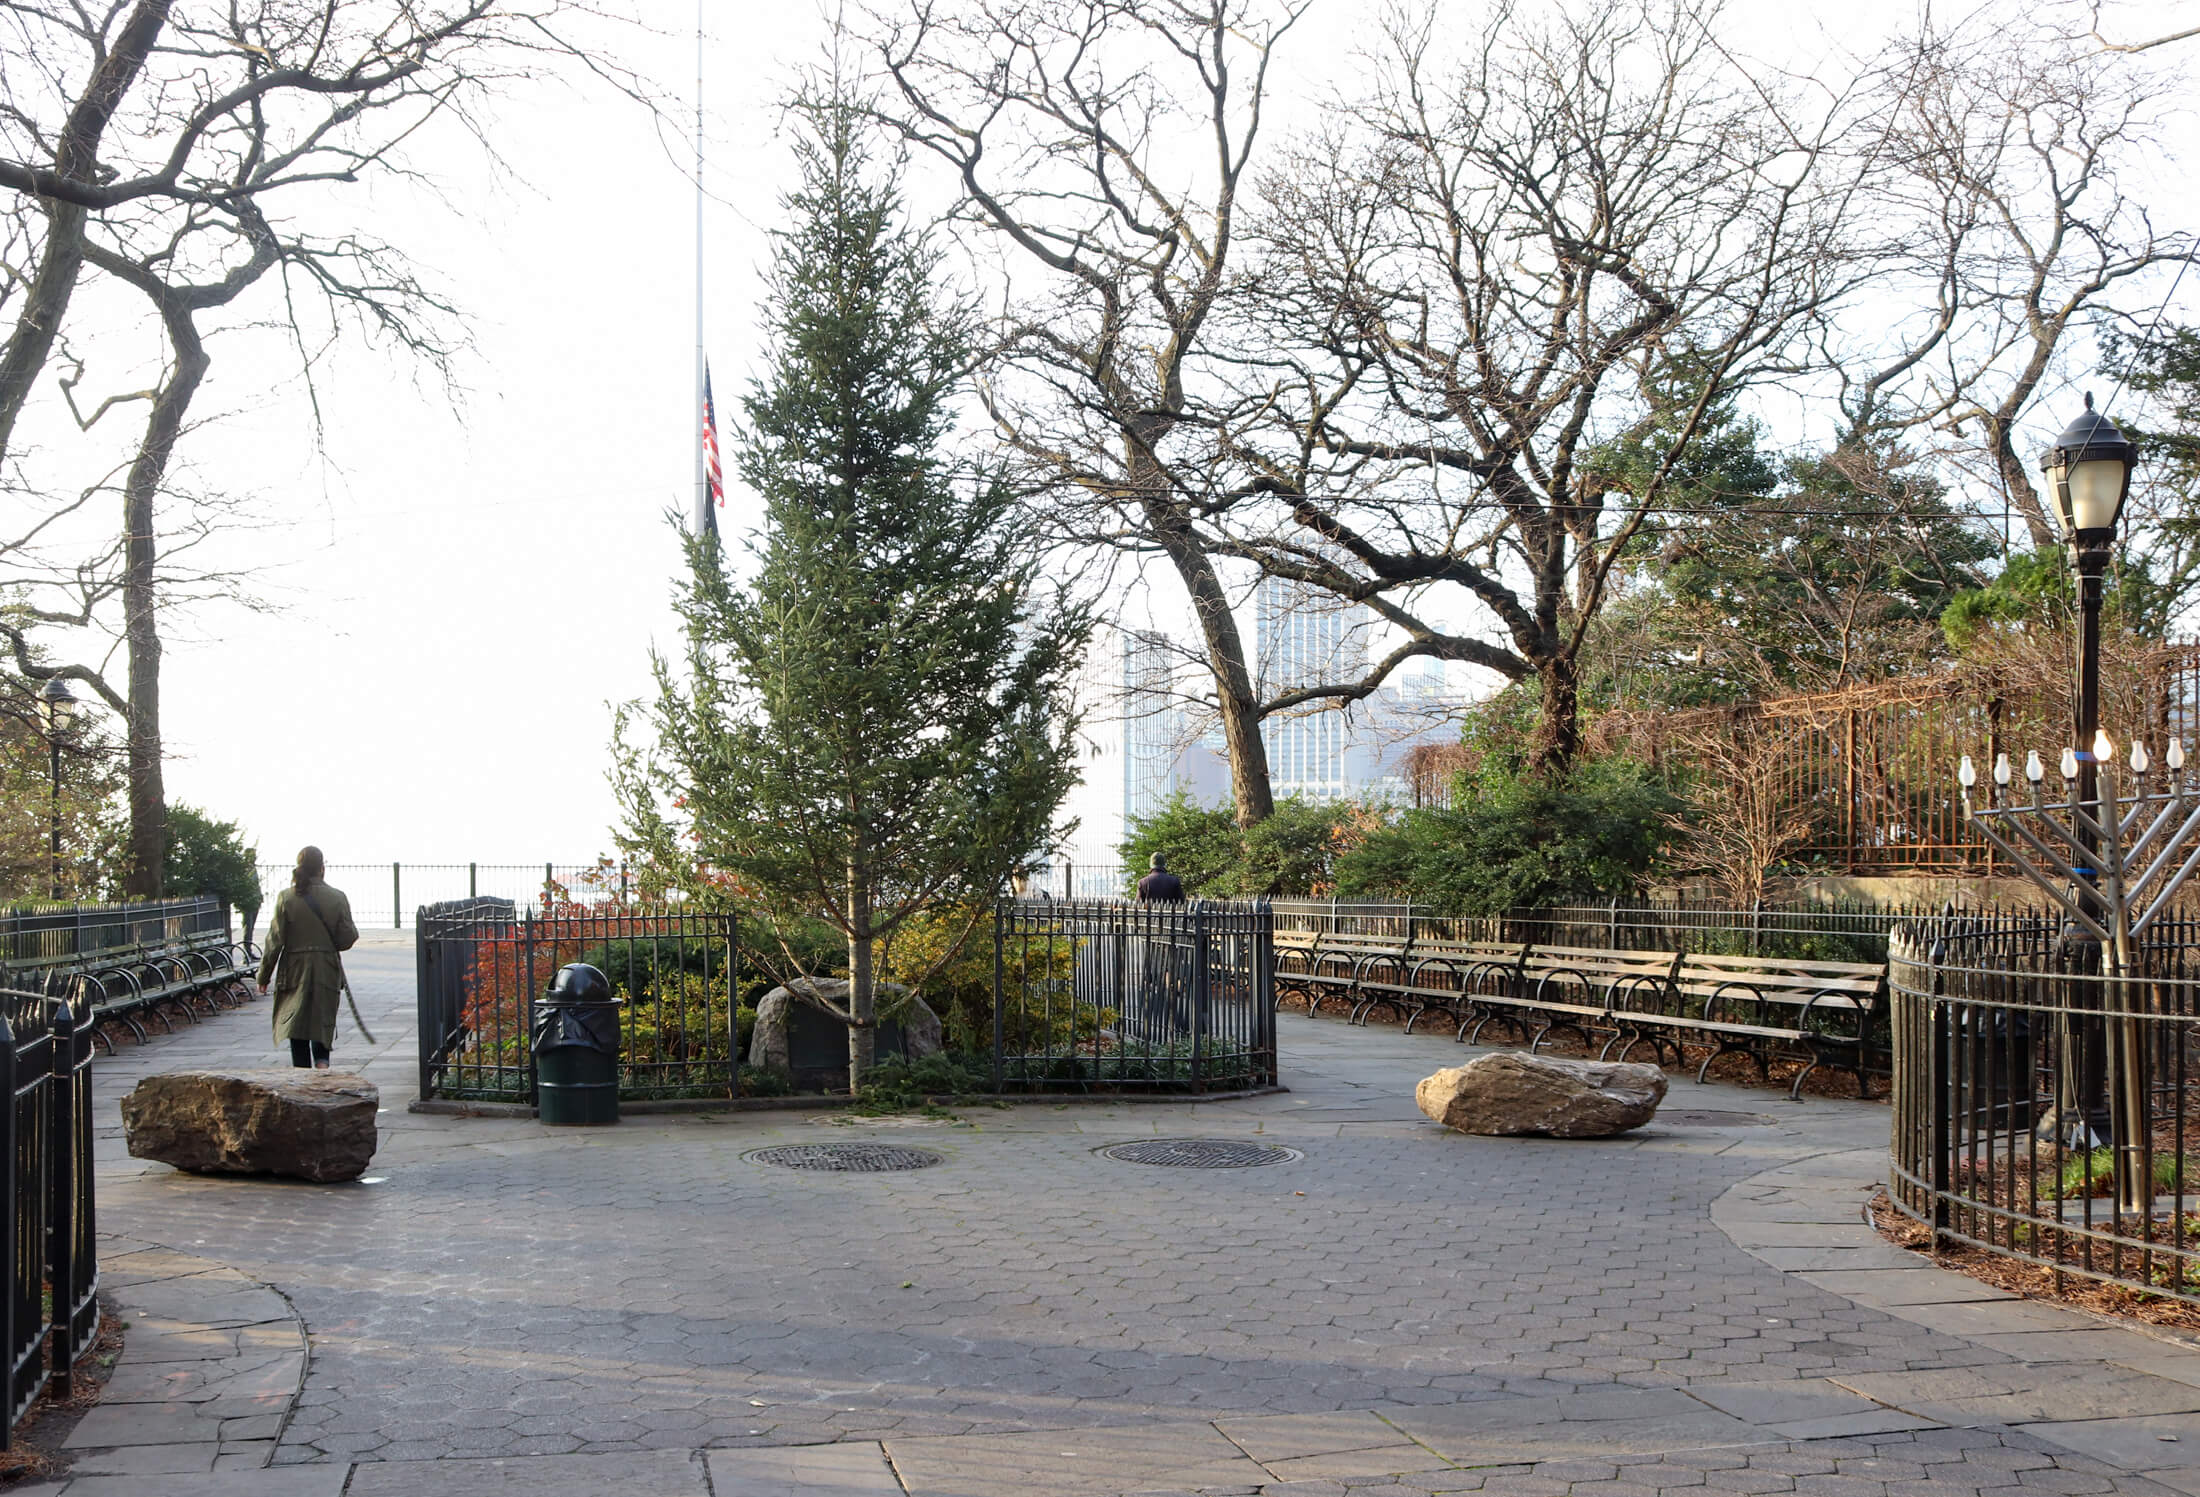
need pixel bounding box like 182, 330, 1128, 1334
1888, 916, 2200, 1303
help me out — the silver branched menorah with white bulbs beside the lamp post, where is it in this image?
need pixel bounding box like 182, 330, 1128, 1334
1956, 733, 2200, 1215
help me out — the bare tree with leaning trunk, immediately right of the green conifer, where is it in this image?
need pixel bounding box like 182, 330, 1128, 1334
869, 0, 1307, 826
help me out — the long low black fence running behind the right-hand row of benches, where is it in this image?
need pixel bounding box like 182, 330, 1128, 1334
1274, 898, 2032, 962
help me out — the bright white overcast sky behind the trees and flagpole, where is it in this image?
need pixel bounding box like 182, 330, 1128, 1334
12, 0, 2200, 863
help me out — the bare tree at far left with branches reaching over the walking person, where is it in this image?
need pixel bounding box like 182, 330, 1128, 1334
0, 0, 645, 894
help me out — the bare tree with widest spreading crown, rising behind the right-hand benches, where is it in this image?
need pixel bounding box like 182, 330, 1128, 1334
1201, 4, 1857, 768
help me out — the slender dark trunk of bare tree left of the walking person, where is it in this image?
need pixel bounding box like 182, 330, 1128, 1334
123, 308, 207, 898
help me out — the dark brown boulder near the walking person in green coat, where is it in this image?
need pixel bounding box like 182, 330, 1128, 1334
123, 1070, 381, 1180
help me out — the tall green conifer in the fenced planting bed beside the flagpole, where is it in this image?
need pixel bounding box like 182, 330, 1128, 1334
614, 95, 1089, 1090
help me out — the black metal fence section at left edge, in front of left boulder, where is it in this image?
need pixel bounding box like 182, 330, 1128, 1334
0, 988, 99, 1449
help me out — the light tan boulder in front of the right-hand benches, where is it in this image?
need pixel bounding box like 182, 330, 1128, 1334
1412, 1050, 1665, 1138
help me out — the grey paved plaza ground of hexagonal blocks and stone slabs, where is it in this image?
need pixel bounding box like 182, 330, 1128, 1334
31, 942, 2200, 1497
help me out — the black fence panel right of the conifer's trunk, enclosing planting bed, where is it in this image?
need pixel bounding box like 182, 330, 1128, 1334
992, 898, 1276, 1092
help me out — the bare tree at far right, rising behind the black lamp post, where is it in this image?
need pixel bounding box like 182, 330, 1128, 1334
1833, 11, 2196, 548
